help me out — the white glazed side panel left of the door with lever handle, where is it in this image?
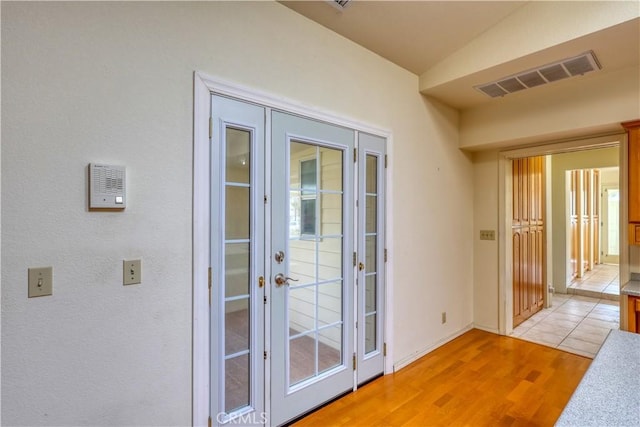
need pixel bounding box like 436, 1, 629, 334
209, 96, 265, 424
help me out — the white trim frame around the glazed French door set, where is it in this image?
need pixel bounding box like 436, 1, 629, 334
192, 71, 394, 426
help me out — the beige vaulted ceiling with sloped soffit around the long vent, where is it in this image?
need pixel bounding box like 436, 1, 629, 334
281, 0, 640, 110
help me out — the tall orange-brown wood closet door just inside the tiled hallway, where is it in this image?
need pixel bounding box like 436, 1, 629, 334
511, 157, 545, 327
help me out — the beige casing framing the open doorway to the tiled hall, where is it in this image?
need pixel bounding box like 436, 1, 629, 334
498, 132, 629, 335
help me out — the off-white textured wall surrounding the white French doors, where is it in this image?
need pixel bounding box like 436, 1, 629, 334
1, 2, 473, 425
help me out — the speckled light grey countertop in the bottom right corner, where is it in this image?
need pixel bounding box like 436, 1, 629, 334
556, 330, 640, 427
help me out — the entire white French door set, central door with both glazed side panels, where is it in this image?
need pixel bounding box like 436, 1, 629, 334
210, 95, 385, 426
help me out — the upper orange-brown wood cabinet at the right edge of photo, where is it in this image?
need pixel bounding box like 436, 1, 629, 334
622, 120, 640, 245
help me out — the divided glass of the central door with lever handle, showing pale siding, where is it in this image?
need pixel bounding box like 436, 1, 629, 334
286, 141, 344, 392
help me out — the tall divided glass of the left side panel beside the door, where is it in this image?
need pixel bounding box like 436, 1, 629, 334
224, 128, 252, 413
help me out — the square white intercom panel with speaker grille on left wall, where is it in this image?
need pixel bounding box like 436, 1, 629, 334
89, 163, 126, 209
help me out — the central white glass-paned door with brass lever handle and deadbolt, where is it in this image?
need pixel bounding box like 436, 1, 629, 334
271, 112, 355, 425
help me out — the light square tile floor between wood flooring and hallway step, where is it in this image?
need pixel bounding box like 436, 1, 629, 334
512, 294, 620, 358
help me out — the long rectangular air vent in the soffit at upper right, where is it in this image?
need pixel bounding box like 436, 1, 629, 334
474, 51, 600, 98
